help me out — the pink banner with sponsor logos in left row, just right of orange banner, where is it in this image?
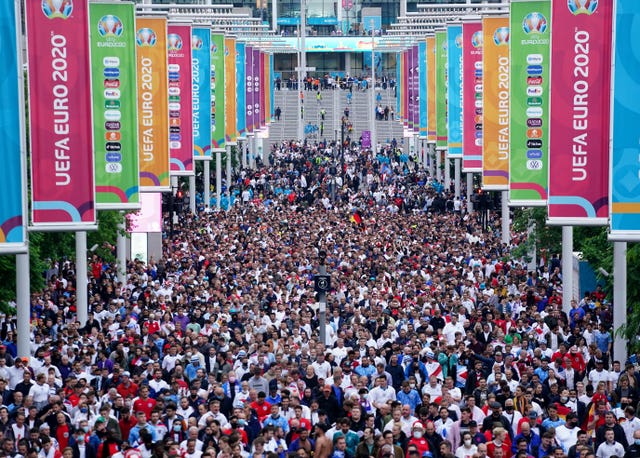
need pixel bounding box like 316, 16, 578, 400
167, 24, 194, 175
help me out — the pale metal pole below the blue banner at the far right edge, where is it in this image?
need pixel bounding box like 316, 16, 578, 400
609, 242, 627, 366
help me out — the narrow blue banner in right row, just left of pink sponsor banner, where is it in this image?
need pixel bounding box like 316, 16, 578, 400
447, 25, 462, 158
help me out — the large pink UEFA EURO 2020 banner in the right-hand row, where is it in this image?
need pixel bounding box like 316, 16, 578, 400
548, 1, 613, 225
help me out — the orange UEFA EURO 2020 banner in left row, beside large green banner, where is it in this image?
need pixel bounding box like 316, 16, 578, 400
136, 17, 170, 192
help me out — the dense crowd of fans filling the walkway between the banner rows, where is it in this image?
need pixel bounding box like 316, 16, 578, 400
0, 142, 640, 458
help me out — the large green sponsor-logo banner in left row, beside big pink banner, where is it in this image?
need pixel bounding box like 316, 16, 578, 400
89, 2, 140, 210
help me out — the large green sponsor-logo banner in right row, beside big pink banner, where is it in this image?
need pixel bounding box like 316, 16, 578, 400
509, 0, 551, 206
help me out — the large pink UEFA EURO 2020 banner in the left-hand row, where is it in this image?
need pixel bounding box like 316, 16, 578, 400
26, 0, 96, 230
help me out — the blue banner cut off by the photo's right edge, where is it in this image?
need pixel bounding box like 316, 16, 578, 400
609, 0, 640, 241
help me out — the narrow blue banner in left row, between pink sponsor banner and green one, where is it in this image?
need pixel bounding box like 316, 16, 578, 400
191, 27, 211, 159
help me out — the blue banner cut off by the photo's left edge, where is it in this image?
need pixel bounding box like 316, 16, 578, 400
0, 0, 26, 253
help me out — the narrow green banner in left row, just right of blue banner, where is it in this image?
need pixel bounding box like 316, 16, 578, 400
211, 34, 225, 152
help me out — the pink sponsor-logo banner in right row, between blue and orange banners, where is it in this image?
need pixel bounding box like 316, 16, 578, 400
462, 21, 483, 172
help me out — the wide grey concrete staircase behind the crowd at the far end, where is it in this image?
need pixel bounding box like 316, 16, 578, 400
268, 88, 402, 148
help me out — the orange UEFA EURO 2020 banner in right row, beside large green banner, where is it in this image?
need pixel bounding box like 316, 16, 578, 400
482, 16, 510, 191
